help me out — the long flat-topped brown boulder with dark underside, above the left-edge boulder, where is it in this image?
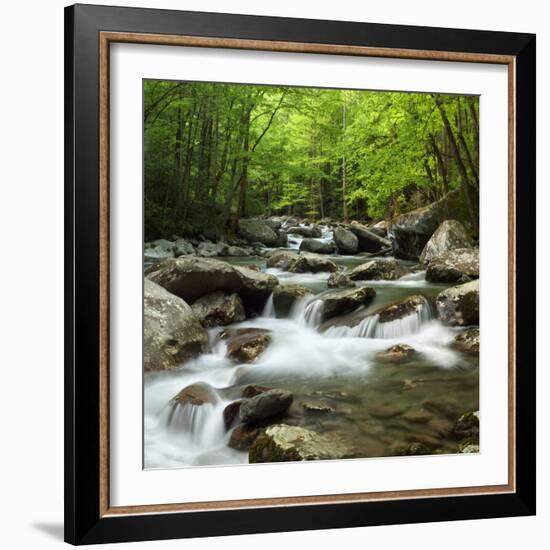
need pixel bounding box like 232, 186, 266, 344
147, 256, 279, 309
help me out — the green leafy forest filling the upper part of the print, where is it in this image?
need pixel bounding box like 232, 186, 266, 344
143, 80, 479, 240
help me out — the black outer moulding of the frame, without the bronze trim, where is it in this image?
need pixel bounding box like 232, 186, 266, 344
65, 5, 536, 544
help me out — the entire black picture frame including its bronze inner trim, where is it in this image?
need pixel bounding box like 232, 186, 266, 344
65, 5, 535, 544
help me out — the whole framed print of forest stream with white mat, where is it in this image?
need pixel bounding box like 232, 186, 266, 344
65, 5, 536, 544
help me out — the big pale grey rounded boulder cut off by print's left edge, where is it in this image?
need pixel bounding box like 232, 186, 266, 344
143, 279, 208, 372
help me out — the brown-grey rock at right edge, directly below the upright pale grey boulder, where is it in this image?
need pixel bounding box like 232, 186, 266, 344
426, 248, 479, 283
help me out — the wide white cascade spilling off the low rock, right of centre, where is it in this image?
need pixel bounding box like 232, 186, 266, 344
325, 300, 433, 339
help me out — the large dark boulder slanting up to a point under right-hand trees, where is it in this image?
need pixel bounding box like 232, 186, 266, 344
388, 190, 464, 260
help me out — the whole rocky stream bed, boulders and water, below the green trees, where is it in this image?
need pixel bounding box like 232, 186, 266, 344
143, 196, 479, 468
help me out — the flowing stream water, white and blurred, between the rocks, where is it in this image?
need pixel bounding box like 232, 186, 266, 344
144, 229, 479, 468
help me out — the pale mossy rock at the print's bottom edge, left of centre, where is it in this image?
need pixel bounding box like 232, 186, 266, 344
248, 424, 356, 463
